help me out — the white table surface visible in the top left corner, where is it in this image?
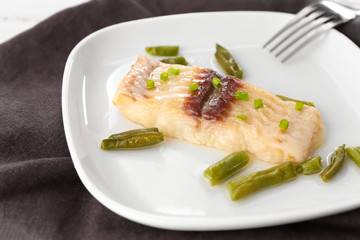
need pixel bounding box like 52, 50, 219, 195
0, 0, 89, 43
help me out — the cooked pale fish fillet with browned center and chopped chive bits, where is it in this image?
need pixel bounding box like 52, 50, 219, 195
113, 56, 324, 163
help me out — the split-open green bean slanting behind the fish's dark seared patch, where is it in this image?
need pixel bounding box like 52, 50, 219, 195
215, 44, 243, 79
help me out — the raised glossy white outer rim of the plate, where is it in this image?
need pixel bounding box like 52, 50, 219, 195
61, 11, 360, 231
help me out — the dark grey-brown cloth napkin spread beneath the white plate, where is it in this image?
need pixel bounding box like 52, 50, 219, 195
0, 0, 360, 240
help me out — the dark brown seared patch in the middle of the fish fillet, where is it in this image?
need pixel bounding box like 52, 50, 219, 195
183, 68, 241, 121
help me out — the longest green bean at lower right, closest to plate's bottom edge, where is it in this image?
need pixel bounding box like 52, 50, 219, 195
227, 162, 297, 201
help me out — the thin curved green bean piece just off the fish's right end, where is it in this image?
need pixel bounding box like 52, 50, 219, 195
320, 144, 345, 182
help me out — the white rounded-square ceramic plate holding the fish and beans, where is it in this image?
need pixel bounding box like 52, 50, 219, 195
62, 12, 360, 230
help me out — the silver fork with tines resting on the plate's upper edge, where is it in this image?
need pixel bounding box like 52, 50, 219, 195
263, 1, 360, 62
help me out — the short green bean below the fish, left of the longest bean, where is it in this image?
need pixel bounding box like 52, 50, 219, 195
204, 152, 249, 186
